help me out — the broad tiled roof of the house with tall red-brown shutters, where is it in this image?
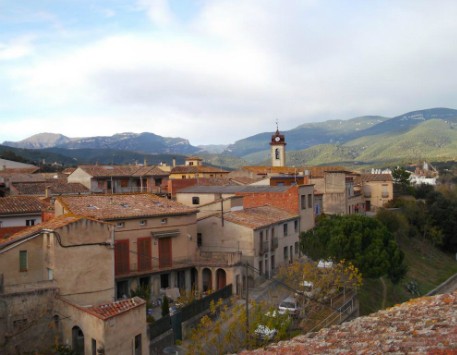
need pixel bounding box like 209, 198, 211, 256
57, 194, 197, 220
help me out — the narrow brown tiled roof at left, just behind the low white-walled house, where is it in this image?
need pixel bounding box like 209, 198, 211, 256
12, 181, 90, 196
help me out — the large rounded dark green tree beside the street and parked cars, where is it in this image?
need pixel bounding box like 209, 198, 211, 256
300, 215, 406, 281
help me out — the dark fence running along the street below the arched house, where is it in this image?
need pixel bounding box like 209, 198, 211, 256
148, 284, 232, 340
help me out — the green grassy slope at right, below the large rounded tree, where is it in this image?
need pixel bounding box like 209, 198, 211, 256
359, 238, 457, 315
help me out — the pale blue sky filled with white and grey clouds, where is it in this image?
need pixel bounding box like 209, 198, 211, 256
0, 0, 457, 145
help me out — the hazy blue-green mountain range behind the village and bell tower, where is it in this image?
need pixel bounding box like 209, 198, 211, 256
0, 108, 457, 168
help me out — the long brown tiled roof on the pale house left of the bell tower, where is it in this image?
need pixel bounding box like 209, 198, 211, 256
79, 165, 168, 177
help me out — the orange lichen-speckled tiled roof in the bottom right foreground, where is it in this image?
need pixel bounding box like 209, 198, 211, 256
241, 293, 457, 355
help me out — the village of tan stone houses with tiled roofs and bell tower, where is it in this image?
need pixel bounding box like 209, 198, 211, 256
0, 130, 414, 354
